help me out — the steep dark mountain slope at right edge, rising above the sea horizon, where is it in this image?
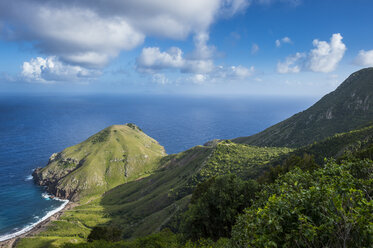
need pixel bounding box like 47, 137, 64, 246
233, 68, 373, 147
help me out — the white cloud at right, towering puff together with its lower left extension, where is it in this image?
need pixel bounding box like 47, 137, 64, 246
277, 33, 347, 73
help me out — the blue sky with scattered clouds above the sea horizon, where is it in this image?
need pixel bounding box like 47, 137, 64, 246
0, 0, 373, 96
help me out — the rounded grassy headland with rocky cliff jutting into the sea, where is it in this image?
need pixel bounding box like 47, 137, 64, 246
33, 124, 166, 200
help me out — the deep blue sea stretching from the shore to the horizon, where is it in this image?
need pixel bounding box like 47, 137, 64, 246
0, 95, 315, 239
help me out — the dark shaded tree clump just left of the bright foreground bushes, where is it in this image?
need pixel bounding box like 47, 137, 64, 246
182, 174, 258, 241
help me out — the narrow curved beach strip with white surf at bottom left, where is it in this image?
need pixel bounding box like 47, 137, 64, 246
0, 201, 78, 248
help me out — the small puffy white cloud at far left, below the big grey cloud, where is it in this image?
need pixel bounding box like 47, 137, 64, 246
22, 57, 99, 83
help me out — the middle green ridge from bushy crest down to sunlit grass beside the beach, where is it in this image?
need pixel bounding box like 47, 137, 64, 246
18, 141, 291, 247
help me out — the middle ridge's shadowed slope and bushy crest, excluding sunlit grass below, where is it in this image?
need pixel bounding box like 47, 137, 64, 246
101, 142, 290, 237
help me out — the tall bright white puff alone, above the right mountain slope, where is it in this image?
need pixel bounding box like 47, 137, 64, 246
308, 33, 347, 72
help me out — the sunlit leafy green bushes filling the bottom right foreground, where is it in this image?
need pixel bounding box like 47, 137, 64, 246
232, 160, 373, 247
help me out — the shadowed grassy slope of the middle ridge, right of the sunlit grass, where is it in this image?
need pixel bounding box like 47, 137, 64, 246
100, 147, 210, 238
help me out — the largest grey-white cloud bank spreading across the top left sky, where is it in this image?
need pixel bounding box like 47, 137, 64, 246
0, 0, 249, 68
